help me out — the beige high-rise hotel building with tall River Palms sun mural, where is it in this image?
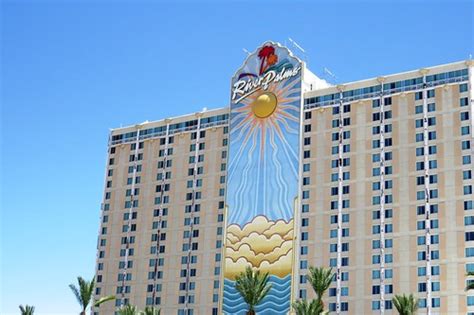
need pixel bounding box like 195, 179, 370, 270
95, 42, 474, 314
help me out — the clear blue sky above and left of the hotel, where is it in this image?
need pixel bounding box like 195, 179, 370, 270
0, 0, 474, 314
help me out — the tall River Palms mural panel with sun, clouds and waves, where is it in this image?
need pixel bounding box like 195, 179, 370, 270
222, 42, 303, 314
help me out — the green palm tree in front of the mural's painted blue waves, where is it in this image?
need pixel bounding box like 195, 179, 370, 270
235, 267, 272, 315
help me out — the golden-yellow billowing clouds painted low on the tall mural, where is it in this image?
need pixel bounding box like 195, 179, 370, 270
225, 216, 293, 280
